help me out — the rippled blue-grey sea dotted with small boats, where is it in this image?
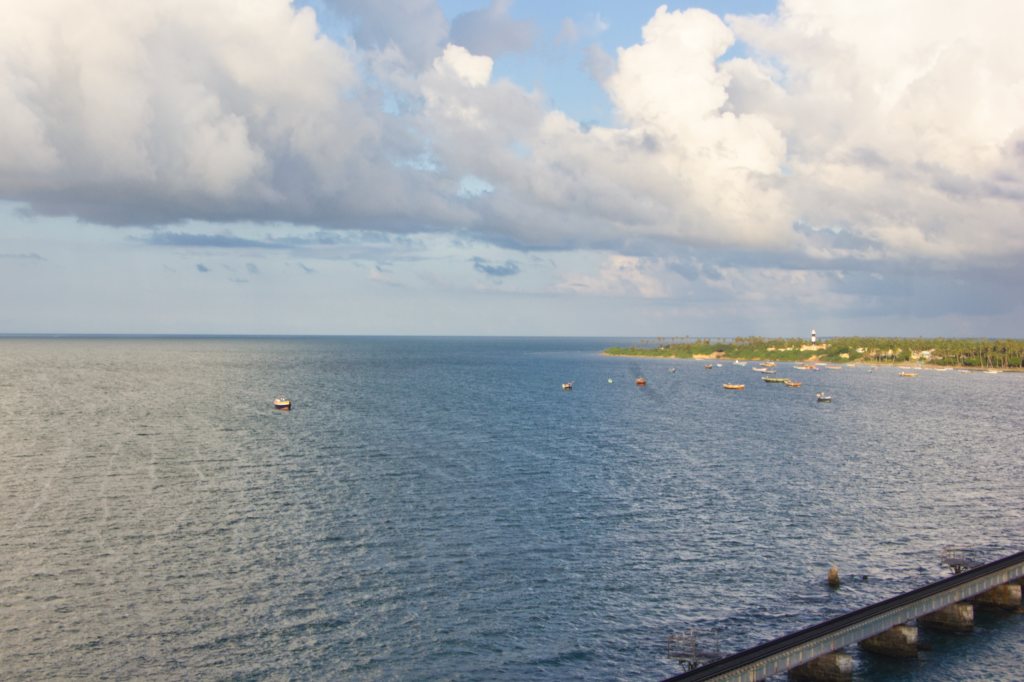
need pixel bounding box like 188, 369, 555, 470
0, 337, 1024, 681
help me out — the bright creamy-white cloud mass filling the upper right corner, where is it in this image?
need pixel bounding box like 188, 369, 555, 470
730, 0, 1024, 262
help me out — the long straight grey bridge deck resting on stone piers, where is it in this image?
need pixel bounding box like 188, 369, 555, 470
666, 552, 1024, 682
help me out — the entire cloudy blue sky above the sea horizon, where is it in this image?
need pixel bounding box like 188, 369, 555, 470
0, 0, 1024, 338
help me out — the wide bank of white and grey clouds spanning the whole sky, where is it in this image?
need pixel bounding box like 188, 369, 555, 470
0, 0, 1024, 333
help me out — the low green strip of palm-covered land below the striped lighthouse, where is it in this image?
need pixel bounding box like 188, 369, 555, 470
604, 336, 1024, 371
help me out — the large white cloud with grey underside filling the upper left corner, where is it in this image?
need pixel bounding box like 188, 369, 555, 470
0, 0, 458, 229
